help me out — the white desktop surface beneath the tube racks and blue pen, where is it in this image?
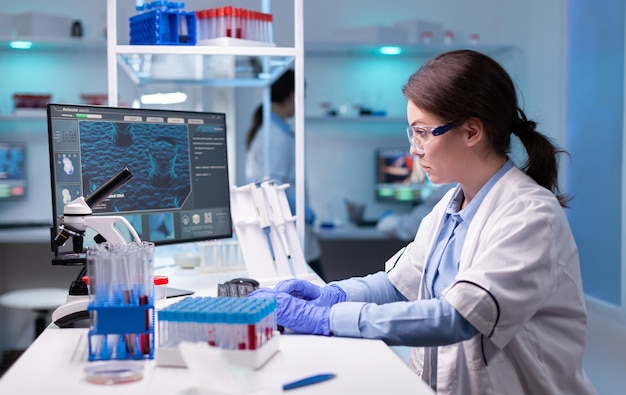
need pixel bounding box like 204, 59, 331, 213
0, 268, 433, 395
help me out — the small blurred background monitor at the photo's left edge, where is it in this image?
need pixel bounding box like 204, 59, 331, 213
0, 141, 27, 201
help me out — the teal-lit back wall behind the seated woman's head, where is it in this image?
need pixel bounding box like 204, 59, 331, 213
304, 0, 567, 223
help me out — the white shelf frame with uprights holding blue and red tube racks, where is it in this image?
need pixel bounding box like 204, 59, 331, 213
107, 0, 305, 243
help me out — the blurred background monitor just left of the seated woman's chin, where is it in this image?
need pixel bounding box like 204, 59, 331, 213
375, 147, 430, 204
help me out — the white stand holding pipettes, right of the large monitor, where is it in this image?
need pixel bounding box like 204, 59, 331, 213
230, 180, 315, 284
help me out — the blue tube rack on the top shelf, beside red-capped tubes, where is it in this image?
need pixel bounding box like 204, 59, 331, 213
129, 9, 197, 45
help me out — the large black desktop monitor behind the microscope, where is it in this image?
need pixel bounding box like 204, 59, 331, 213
47, 104, 232, 256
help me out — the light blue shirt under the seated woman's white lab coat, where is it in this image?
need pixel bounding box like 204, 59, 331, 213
330, 159, 513, 347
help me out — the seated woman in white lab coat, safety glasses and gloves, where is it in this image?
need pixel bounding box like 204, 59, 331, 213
252, 50, 595, 395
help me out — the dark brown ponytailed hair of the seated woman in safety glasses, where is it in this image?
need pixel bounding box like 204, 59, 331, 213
402, 50, 570, 207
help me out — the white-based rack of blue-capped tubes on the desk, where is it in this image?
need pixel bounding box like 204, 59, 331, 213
155, 297, 279, 369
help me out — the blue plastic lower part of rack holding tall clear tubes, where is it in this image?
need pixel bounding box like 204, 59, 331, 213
87, 303, 155, 361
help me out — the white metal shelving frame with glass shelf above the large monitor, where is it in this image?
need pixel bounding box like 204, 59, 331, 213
107, 0, 304, 244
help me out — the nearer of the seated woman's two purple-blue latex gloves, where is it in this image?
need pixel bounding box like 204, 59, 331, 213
248, 288, 330, 336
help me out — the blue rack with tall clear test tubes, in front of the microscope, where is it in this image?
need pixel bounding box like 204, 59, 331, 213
87, 242, 155, 361
